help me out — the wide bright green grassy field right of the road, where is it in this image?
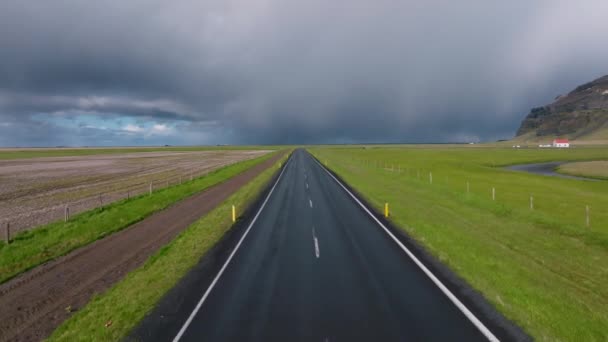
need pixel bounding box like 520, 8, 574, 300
310, 146, 608, 341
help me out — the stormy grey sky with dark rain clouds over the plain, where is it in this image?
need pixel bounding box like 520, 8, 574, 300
0, 0, 608, 146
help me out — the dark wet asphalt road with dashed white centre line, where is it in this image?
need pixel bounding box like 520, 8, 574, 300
175, 150, 494, 342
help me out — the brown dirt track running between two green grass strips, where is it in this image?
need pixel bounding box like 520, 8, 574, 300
0, 155, 281, 341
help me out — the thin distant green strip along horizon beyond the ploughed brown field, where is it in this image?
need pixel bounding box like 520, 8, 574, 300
0, 145, 284, 160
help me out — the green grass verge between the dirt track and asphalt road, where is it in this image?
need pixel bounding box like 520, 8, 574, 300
49, 153, 287, 341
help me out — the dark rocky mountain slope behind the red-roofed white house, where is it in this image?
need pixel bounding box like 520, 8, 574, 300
516, 75, 608, 140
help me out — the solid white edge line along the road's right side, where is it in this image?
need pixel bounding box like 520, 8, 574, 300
313, 158, 500, 341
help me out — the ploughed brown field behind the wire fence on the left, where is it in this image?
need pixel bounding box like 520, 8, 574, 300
0, 151, 267, 233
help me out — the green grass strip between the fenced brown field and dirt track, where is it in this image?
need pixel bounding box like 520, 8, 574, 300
0, 153, 273, 283
